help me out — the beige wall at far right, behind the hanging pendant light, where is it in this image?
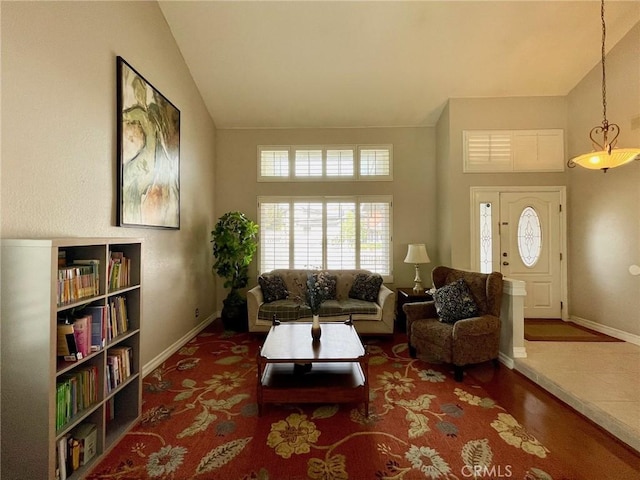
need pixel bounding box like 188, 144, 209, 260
567, 24, 640, 335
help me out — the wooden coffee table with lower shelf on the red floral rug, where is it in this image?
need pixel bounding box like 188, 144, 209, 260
257, 321, 369, 416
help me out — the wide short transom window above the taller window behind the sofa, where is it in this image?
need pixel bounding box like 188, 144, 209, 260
258, 145, 393, 182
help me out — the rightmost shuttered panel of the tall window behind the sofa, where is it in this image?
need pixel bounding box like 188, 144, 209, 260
360, 202, 391, 275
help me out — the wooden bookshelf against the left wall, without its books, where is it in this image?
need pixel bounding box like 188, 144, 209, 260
0, 238, 142, 480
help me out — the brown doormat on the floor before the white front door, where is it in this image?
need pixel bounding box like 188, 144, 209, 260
524, 318, 624, 342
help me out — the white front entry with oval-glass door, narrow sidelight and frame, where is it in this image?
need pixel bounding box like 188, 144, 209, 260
471, 187, 566, 318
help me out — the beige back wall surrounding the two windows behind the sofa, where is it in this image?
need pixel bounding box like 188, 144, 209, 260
215, 128, 438, 305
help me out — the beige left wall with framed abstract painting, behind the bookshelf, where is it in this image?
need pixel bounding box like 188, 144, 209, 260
1, 2, 215, 364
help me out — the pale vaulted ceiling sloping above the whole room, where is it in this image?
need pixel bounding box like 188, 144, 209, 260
160, 0, 640, 128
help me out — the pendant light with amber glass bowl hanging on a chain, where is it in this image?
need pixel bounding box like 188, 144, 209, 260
567, 0, 640, 173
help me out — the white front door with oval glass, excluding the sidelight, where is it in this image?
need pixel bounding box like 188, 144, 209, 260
499, 192, 562, 318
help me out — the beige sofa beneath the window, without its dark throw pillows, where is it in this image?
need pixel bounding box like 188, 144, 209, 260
247, 269, 395, 334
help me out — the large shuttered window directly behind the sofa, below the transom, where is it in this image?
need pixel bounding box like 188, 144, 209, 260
258, 196, 392, 281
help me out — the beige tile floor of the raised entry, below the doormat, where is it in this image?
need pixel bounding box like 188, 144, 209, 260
514, 341, 640, 452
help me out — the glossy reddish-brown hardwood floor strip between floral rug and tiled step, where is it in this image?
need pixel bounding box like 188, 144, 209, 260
466, 362, 640, 480
